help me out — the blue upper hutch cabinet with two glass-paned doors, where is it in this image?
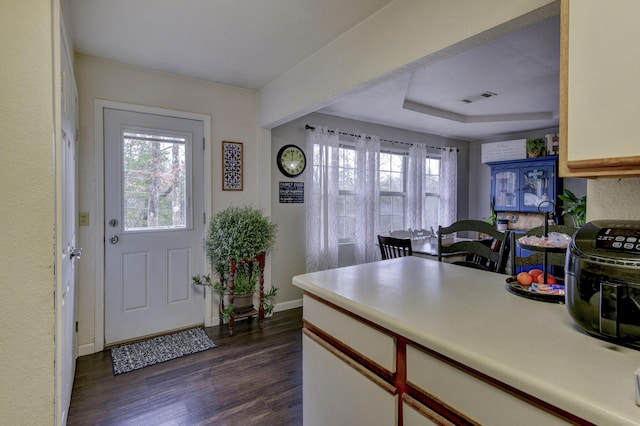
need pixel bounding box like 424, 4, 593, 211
488, 156, 560, 213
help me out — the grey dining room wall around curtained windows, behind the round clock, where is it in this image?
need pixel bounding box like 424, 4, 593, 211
271, 113, 469, 301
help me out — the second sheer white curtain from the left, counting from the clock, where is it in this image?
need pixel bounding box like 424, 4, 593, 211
355, 135, 380, 264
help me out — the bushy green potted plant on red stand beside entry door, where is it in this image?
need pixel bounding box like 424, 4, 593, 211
193, 206, 278, 318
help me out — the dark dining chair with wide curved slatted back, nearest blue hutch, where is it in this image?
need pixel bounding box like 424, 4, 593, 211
438, 220, 510, 273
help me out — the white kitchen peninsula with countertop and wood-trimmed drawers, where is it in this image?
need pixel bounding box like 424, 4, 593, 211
293, 256, 640, 426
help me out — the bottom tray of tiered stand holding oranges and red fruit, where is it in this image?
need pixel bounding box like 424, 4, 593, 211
506, 268, 564, 303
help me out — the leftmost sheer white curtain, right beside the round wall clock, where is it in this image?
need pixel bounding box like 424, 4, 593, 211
305, 126, 340, 272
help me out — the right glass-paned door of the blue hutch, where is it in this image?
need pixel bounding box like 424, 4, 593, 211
519, 165, 556, 212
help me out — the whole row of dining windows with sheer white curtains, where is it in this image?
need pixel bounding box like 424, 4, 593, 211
307, 127, 457, 271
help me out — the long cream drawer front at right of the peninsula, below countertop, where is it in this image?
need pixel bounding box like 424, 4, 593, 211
407, 345, 567, 426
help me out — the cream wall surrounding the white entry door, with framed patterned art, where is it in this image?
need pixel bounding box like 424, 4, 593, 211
75, 56, 262, 355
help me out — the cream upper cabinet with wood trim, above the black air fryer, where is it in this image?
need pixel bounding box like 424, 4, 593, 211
560, 0, 640, 177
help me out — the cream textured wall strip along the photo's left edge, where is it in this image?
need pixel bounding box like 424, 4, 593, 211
0, 0, 59, 424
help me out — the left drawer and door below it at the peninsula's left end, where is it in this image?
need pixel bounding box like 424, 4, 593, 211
302, 295, 398, 426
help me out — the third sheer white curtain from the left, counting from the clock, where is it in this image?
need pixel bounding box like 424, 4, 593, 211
406, 144, 427, 229
